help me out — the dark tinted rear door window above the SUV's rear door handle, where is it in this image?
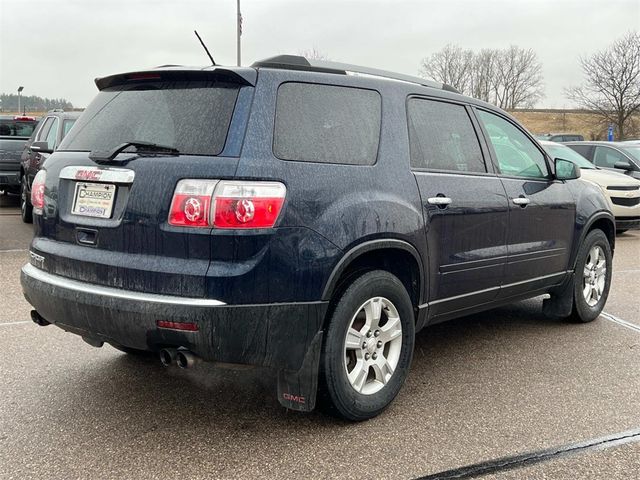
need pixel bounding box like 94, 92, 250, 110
407, 98, 487, 172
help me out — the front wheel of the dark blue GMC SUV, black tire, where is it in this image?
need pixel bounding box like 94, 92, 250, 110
570, 230, 613, 323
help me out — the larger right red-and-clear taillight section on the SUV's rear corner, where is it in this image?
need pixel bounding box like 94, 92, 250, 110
213, 182, 286, 228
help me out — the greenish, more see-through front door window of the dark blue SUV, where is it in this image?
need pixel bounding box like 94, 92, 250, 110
478, 110, 549, 178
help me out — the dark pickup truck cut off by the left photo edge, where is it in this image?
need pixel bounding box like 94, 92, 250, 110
0, 115, 38, 193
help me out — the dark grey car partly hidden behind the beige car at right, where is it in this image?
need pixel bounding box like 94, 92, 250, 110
566, 142, 640, 179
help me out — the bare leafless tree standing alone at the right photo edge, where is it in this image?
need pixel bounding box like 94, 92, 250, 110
565, 32, 640, 140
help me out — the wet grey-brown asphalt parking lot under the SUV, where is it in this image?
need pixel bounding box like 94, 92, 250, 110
0, 192, 640, 479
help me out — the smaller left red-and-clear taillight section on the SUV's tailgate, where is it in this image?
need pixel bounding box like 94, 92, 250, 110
169, 180, 218, 227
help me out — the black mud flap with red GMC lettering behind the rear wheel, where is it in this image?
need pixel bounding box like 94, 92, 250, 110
278, 331, 322, 412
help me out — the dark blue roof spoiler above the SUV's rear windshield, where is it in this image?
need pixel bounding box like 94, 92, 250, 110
95, 67, 258, 90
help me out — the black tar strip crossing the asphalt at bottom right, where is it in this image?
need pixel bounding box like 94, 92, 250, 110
416, 428, 640, 480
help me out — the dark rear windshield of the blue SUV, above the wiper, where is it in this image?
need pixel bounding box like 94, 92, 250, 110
58, 81, 239, 155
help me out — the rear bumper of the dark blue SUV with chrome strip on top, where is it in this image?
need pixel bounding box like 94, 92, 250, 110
21, 264, 328, 370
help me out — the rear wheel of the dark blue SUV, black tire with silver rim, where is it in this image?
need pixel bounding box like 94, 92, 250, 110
318, 270, 415, 421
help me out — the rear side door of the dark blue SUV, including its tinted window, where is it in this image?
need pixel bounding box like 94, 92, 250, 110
407, 97, 508, 317
